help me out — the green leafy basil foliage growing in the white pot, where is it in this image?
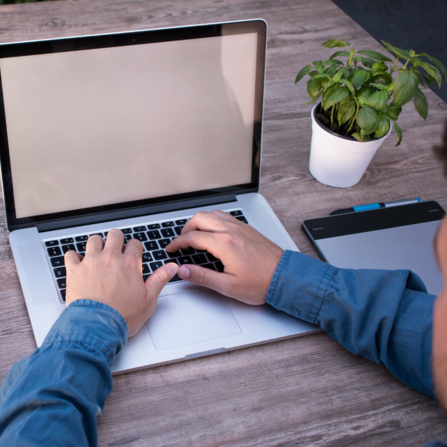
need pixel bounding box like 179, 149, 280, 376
295, 39, 447, 146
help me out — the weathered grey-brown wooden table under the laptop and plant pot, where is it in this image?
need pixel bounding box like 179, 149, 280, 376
0, 0, 447, 446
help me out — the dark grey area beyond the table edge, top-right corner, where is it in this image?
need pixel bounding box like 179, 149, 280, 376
332, 0, 447, 102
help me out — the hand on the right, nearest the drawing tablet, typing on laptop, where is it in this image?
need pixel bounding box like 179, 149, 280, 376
166, 210, 283, 305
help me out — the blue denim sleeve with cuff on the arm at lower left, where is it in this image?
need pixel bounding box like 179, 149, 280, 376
0, 300, 128, 447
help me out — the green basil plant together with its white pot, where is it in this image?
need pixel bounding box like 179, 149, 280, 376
295, 39, 447, 187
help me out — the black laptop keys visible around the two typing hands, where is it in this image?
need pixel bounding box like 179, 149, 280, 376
43, 210, 248, 302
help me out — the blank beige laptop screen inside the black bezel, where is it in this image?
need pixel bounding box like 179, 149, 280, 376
0, 33, 257, 218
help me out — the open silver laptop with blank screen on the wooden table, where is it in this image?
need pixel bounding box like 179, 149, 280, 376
0, 20, 316, 373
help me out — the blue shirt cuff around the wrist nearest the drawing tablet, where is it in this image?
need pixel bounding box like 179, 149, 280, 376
266, 250, 338, 324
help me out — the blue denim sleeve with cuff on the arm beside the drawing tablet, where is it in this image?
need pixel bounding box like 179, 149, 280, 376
266, 251, 436, 397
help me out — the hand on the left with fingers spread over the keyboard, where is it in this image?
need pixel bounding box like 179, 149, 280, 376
65, 230, 178, 337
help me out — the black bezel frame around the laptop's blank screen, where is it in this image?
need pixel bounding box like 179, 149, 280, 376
0, 19, 267, 231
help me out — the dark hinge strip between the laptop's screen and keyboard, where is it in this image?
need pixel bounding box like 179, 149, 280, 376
37, 194, 237, 233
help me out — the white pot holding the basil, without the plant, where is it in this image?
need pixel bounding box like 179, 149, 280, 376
309, 104, 392, 188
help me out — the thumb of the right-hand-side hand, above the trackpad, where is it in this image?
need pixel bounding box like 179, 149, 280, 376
177, 264, 235, 296
